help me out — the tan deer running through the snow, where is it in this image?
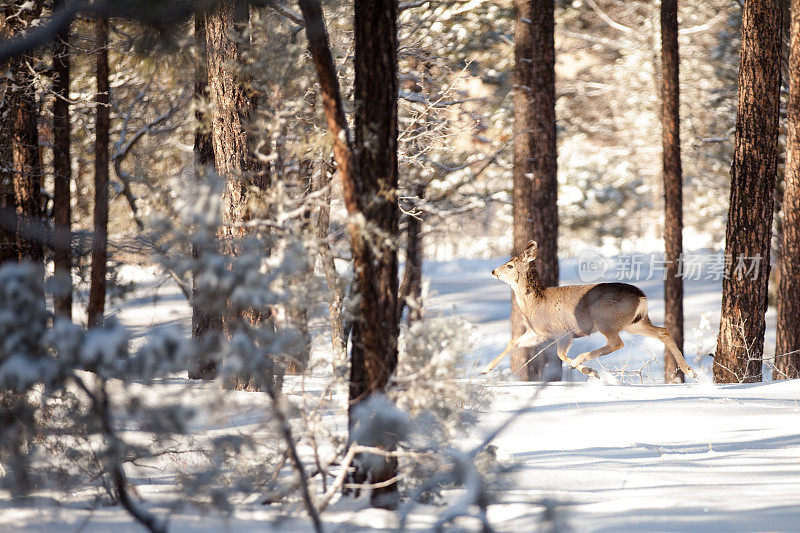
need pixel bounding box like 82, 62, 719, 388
481, 241, 697, 378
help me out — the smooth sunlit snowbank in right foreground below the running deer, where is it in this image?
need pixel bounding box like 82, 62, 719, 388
487, 380, 800, 532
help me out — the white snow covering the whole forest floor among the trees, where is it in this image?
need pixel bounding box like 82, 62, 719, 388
0, 254, 800, 533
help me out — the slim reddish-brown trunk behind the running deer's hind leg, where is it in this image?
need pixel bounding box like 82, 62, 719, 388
661, 0, 684, 383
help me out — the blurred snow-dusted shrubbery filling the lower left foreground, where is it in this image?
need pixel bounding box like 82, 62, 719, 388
0, 167, 323, 527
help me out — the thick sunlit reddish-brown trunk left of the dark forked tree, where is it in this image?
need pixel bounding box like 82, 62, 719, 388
206, 0, 282, 390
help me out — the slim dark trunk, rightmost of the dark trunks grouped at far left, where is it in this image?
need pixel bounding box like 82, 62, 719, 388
88, 17, 111, 327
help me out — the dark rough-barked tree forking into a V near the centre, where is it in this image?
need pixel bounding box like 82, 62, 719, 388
299, 0, 398, 507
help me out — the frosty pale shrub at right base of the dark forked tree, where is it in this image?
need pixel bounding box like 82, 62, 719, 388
338, 313, 482, 501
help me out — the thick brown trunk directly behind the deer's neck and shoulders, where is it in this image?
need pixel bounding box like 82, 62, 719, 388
511, 0, 561, 380
